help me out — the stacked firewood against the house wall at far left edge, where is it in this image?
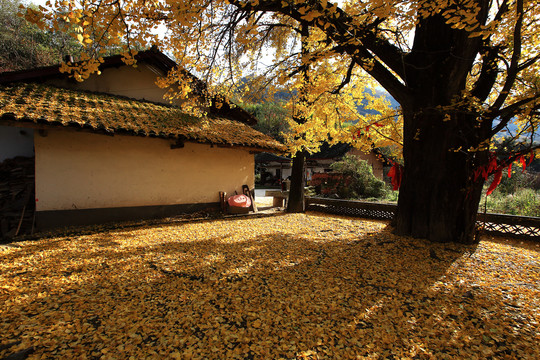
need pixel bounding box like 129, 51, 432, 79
0, 156, 35, 239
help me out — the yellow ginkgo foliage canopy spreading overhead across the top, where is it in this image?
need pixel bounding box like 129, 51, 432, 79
26, 0, 540, 160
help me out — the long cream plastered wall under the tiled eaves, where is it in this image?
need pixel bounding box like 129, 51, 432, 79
35, 129, 254, 211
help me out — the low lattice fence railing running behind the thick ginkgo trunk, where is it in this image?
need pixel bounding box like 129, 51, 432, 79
306, 197, 540, 240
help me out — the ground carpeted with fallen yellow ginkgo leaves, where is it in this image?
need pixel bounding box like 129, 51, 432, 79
0, 213, 540, 359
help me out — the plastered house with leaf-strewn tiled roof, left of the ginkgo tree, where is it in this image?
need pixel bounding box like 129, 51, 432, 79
0, 49, 283, 235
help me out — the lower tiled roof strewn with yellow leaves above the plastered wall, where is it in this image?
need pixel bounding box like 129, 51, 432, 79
0, 83, 284, 152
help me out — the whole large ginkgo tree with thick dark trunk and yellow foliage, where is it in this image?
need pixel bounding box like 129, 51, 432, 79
26, 0, 540, 242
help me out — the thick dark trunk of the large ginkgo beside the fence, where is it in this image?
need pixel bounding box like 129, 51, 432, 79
395, 8, 491, 243
